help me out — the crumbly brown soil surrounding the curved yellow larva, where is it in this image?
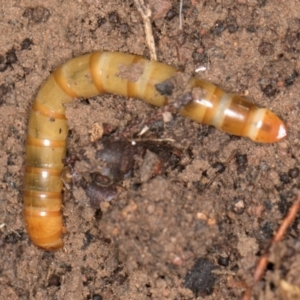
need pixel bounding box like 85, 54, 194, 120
0, 0, 300, 300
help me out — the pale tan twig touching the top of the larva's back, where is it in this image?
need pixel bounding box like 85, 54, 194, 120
134, 0, 157, 60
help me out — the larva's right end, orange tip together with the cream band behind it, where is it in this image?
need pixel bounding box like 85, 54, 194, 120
249, 108, 287, 143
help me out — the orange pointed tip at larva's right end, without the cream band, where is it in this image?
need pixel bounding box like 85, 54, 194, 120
255, 109, 287, 143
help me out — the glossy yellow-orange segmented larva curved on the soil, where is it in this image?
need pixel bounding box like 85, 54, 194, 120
24, 52, 286, 251
